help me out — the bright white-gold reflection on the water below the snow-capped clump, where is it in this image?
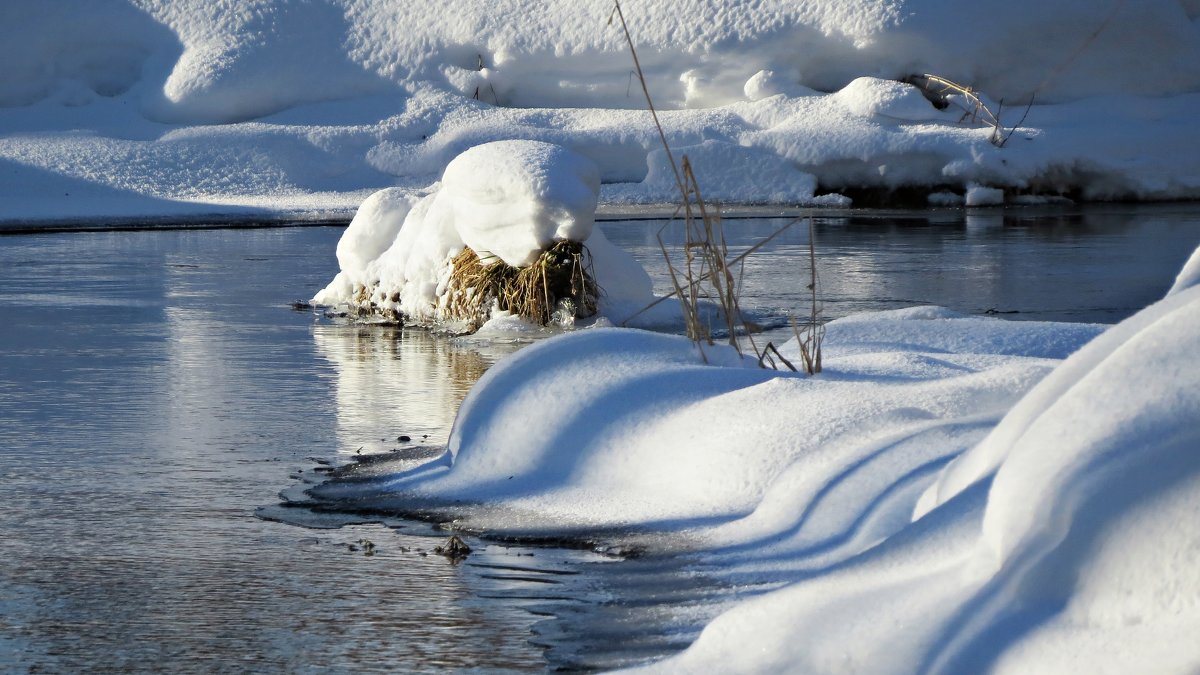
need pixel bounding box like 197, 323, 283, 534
313, 324, 514, 454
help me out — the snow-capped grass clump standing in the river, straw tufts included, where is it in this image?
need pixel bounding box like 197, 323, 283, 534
313, 141, 652, 329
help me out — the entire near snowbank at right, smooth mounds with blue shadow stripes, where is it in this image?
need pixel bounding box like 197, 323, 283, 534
297, 246, 1200, 674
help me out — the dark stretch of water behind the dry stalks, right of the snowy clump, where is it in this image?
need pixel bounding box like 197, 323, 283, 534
602, 204, 1200, 339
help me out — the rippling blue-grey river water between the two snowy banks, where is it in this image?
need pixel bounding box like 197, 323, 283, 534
0, 205, 1200, 673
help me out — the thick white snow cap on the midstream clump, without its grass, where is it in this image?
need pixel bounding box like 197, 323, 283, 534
313, 141, 653, 324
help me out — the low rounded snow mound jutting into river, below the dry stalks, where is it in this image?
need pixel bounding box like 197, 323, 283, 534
304, 307, 1098, 535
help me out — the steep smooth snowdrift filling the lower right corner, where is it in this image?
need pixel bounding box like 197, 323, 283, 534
656, 261, 1200, 674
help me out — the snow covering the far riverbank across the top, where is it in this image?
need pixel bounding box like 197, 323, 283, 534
0, 0, 1200, 223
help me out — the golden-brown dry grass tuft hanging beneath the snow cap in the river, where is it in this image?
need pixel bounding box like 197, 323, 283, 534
446, 240, 601, 330
